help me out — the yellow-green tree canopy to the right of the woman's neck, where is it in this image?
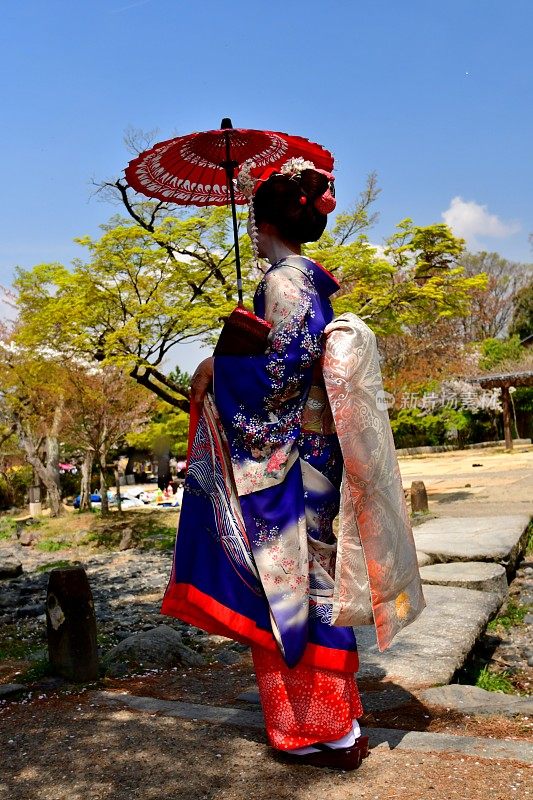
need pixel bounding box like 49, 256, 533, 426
308, 212, 486, 335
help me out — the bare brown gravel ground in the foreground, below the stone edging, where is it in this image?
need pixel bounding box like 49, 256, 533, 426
0, 696, 533, 800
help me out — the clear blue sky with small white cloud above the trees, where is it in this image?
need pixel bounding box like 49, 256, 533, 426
0, 0, 533, 368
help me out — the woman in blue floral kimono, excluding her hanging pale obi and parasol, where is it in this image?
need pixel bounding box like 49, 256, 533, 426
161, 159, 424, 770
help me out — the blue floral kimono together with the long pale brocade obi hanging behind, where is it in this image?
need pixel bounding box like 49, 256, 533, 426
161, 256, 425, 673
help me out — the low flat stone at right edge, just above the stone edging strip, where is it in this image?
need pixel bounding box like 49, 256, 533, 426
418, 683, 533, 716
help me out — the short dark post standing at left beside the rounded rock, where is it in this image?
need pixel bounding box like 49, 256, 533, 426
46, 567, 98, 683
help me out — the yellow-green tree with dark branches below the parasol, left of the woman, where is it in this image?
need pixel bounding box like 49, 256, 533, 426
14, 203, 254, 410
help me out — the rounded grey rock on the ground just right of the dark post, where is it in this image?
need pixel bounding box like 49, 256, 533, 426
103, 625, 205, 674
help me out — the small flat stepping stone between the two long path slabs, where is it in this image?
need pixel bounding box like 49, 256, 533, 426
420, 561, 509, 603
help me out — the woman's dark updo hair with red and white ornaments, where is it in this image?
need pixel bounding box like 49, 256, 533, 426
253, 169, 332, 244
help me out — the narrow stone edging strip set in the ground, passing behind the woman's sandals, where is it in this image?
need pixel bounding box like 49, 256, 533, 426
94, 691, 533, 764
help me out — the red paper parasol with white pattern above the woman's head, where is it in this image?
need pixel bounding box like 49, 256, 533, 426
125, 119, 333, 304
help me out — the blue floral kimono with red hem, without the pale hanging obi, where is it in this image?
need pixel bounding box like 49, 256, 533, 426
161, 256, 358, 673
